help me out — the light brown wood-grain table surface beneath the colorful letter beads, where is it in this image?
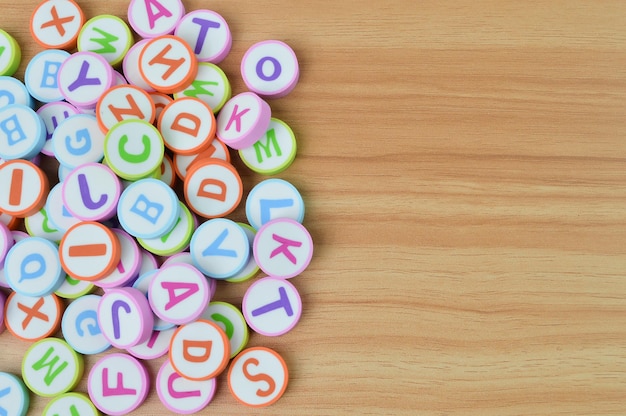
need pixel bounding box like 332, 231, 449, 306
0, 0, 626, 415
